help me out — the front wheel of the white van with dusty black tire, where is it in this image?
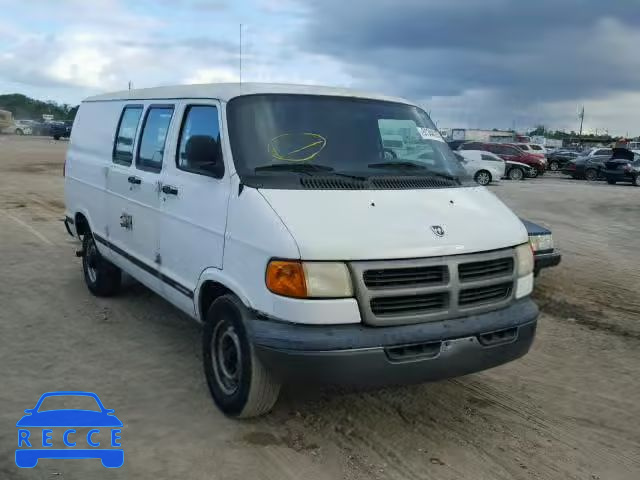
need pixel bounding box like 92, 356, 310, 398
202, 294, 280, 418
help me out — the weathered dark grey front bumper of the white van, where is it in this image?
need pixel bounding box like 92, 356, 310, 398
249, 298, 538, 386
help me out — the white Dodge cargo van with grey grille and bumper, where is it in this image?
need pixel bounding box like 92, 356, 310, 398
65, 84, 538, 417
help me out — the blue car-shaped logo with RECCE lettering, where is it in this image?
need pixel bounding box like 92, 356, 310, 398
16, 391, 124, 468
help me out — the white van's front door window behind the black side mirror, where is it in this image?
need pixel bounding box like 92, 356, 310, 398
176, 105, 224, 178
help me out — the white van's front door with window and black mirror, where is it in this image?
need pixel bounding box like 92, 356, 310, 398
160, 100, 230, 315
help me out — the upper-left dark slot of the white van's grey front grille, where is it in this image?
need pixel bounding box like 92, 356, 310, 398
363, 265, 449, 288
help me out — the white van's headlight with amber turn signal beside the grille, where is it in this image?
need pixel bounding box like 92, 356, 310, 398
265, 260, 353, 298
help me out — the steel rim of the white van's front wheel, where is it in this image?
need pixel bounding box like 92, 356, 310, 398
210, 320, 242, 395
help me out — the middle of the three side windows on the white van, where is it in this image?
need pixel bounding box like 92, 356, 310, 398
136, 106, 173, 172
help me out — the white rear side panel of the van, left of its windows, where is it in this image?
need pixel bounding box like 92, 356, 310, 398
65, 102, 122, 253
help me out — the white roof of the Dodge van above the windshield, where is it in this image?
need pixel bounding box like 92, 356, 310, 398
84, 83, 413, 105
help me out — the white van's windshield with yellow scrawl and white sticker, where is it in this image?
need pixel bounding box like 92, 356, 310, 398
227, 94, 468, 188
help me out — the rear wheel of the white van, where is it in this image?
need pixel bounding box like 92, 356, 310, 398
82, 232, 122, 297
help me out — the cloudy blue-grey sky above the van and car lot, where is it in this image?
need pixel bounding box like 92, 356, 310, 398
0, 0, 640, 136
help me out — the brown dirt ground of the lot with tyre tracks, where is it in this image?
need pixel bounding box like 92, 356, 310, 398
0, 135, 640, 480
